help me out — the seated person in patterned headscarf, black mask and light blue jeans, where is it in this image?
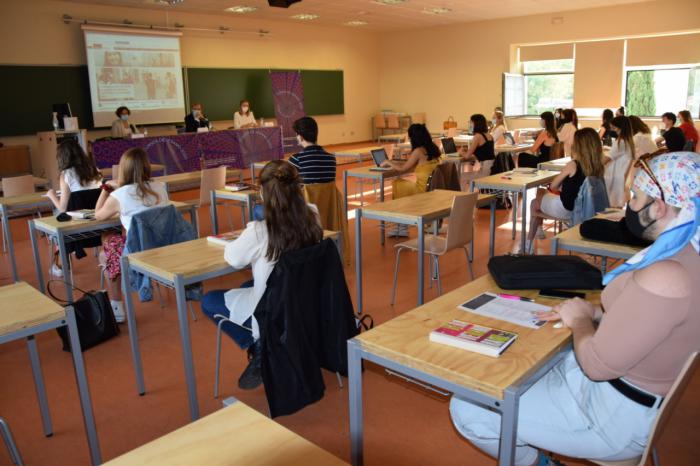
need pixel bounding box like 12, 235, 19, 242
450, 152, 700, 466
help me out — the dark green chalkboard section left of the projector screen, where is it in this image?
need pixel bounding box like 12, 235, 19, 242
0, 65, 92, 136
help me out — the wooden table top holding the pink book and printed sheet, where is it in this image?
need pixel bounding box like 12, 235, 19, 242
355, 275, 600, 399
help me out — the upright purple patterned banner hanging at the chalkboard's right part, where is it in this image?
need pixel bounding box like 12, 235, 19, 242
270, 71, 306, 138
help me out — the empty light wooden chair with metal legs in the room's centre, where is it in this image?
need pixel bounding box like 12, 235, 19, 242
391, 192, 479, 306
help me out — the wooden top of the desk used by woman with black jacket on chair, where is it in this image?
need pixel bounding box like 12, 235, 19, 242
129, 231, 338, 282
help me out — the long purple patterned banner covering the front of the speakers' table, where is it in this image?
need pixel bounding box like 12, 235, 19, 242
92, 126, 284, 174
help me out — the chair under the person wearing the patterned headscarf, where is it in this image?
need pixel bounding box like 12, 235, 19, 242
588, 351, 700, 466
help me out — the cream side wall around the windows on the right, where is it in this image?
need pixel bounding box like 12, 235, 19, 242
379, 0, 700, 129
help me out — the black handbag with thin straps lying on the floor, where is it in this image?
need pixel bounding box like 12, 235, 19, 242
46, 280, 119, 352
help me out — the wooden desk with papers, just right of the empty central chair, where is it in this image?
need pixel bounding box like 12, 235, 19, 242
471, 170, 559, 251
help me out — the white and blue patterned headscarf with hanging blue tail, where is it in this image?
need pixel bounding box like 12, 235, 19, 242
603, 152, 700, 285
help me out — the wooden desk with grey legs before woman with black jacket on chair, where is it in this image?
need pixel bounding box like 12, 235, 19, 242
121, 231, 342, 421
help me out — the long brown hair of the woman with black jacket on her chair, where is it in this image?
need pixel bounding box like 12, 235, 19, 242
260, 160, 323, 261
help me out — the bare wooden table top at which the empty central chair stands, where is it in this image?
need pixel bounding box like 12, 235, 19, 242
362, 189, 491, 222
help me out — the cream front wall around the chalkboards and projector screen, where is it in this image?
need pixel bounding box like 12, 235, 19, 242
0, 0, 379, 169
